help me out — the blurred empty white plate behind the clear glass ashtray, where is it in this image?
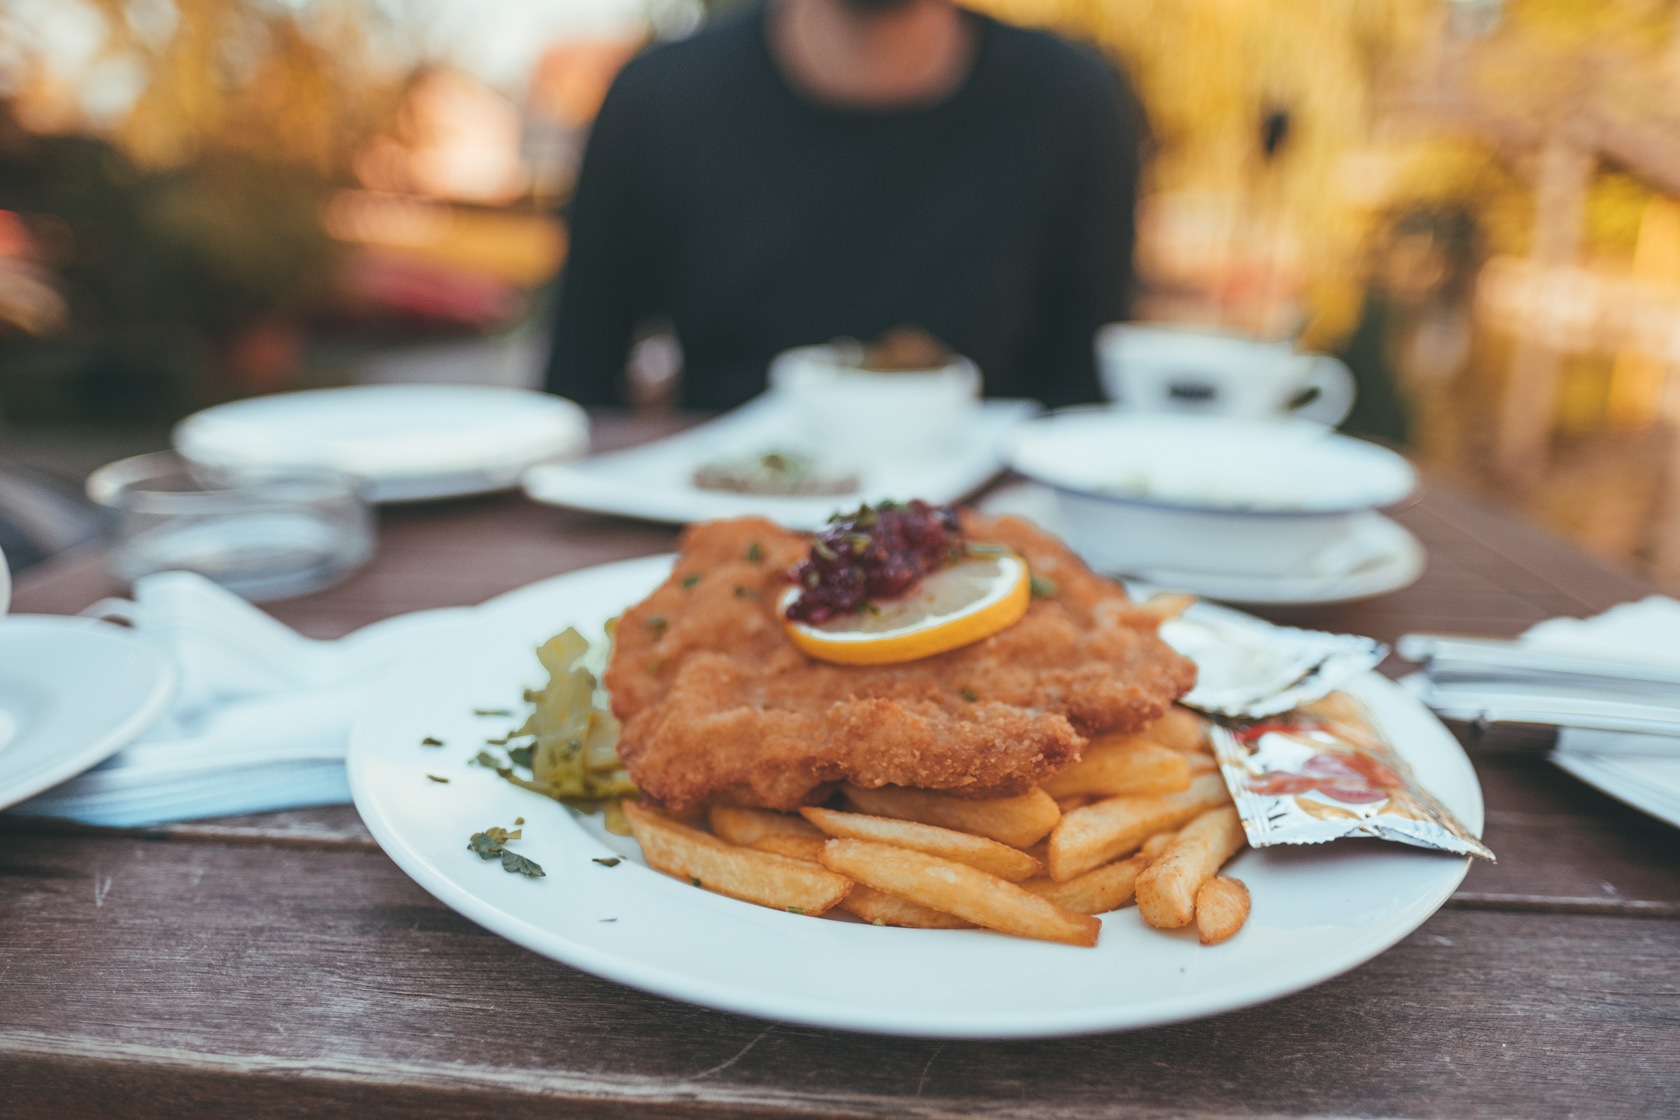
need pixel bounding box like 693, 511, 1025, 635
175, 385, 590, 502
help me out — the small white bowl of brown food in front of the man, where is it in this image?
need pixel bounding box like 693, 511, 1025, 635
769, 346, 979, 463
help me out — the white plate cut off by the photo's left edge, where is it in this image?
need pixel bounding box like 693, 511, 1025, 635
0, 615, 175, 808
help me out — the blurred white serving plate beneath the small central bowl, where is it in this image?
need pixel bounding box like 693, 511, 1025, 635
524, 393, 1038, 529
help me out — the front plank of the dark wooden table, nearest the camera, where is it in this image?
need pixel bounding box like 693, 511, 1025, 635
0, 836, 1680, 1117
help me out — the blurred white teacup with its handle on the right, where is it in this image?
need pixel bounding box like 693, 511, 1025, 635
1097, 322, 1354, 427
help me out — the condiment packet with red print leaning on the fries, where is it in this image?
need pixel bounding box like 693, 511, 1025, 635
1210, 692, 1494, 861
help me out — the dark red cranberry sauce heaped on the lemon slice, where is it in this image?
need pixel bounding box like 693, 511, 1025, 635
788, 500, 963, 625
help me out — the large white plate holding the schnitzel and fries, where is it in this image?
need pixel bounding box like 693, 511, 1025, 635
349, 557, 1482, 1038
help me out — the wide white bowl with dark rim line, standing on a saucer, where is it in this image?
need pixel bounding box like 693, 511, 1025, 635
1010, 410, 1416, 576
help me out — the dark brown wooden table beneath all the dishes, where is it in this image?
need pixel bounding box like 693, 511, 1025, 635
0, 416, 1680, 1120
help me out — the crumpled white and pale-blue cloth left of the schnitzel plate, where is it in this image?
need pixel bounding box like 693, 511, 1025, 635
10, 573, 470, 828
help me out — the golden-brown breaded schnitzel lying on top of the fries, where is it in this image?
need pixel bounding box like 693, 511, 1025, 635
605, 512, 1196, 809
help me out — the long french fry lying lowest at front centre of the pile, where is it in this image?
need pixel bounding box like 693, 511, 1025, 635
823, 840, 1102, 947
